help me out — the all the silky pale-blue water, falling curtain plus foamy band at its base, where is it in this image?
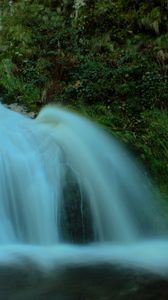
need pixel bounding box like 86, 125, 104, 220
0, 105, 168, 274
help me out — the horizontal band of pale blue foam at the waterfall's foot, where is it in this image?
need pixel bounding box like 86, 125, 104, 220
0, 240, 168, 277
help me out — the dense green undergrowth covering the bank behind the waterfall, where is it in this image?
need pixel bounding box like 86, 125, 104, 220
0, 0, 168, 194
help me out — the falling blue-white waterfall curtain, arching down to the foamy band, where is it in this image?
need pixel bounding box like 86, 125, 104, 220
0, 106, 165, 244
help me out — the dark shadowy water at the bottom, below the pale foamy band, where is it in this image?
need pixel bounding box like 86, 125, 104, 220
0, 262, 168, 300
